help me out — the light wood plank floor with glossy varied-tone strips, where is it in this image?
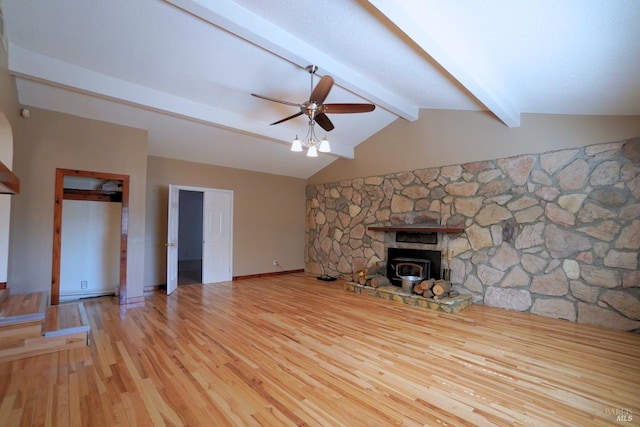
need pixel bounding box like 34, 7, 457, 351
0, 274, 640, 426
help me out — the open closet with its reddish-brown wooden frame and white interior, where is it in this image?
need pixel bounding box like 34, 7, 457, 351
50, 169, 129, 305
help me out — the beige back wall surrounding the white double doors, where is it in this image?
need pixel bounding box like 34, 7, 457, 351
145, 156, 306, 286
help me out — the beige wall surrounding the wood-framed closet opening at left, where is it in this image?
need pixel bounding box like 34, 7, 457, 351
9, 108, 147, 298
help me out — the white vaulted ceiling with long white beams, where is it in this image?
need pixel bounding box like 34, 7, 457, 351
5, 0, 640, 178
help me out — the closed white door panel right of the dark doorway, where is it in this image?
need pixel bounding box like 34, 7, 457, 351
202, 190, 233, 283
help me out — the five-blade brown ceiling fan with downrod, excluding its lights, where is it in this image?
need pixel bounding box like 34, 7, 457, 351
251, 65, 376, 132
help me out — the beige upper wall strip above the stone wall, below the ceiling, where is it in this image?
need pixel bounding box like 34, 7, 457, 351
309, 110, 640, 184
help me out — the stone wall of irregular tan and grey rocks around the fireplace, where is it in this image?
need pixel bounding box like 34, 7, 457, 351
305, 138, 640, 331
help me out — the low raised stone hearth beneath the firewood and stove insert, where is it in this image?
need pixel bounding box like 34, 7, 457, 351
344, 282, 472, 313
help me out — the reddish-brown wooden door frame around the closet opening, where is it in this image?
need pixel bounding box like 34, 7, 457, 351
50, 168, 129, 305
